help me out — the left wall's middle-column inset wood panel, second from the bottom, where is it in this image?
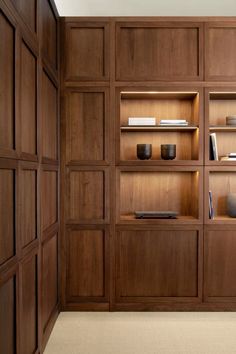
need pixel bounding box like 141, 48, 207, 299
20, 169, 37, 248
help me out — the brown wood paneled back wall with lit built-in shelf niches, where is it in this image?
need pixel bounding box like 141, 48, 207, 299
61, 17, 236, 310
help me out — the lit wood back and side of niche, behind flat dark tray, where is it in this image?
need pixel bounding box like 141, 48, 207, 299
120, 171, 198, 219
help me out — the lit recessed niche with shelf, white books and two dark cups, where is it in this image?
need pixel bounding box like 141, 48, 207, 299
119, 91, 200, 164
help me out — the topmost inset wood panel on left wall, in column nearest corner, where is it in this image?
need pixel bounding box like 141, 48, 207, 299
41, 0, 57, 70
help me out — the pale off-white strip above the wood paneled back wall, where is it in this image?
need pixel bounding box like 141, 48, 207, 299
55, 0, 236, 16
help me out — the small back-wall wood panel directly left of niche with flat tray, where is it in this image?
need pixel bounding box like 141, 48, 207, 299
68, 170, 105, 222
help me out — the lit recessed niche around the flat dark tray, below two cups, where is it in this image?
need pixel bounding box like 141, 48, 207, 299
117, 168, 201, 223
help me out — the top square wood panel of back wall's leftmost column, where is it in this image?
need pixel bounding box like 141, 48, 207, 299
65, 22, 109, 80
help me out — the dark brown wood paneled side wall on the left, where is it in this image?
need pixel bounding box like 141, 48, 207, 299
0, 0, 59, 354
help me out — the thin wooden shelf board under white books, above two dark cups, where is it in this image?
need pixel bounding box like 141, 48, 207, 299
120, 125, 198, 132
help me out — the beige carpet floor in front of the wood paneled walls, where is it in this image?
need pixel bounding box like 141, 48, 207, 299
44, 312, 236, 354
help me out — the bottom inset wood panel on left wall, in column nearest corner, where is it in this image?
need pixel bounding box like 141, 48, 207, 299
41, 235, 58, 331
